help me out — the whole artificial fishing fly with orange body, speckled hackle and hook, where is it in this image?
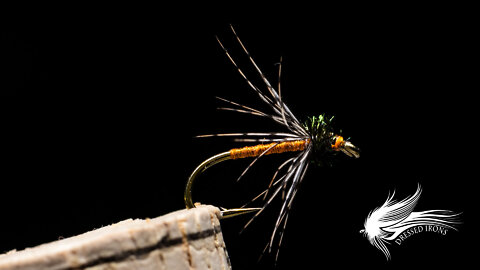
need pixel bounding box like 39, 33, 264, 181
184, 26, 360, 258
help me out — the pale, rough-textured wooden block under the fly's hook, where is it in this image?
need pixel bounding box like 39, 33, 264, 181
0, 206, 231, 270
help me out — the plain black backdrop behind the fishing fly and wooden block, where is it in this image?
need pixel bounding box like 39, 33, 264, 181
0, 2, 478, 269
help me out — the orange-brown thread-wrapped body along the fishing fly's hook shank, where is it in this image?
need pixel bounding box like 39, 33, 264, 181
230, 139, 310, 159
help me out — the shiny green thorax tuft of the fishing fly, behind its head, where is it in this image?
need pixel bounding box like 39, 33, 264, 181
304, 114, 336, 166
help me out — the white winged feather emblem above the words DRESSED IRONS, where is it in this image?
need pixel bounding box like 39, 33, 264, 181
360, 185, 460, 260
